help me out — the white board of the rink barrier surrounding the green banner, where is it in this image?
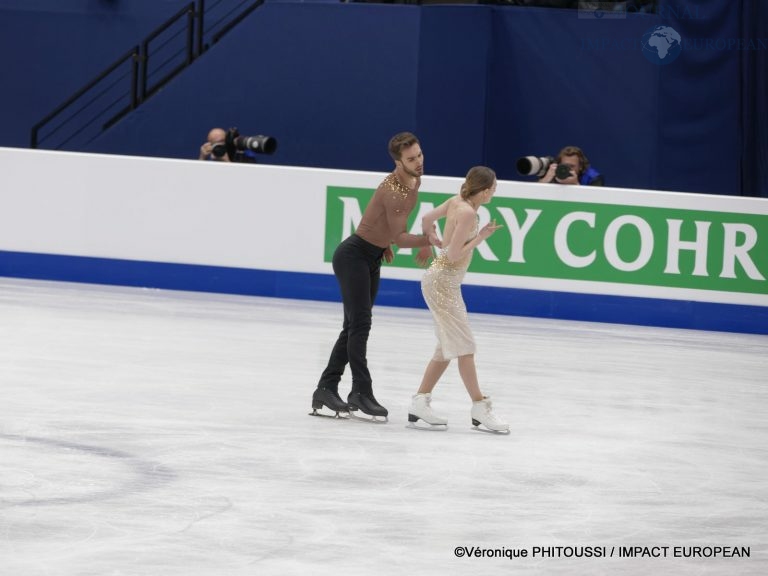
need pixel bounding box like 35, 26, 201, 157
0, 148, 768, 306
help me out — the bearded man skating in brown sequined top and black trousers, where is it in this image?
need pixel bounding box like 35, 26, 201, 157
312, 132, 440, 421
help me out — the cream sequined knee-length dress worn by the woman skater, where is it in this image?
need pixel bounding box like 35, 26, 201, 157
421, 217, 477, 362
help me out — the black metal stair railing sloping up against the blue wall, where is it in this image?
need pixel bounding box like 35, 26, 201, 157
30, 0, 264, 150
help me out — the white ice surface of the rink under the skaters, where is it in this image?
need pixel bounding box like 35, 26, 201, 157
0, 279, 768, 576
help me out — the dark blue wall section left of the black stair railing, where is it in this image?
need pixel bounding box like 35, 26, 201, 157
0, 0, 192, 147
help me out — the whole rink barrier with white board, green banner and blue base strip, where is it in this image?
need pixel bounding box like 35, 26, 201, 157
0, 148, 768, 334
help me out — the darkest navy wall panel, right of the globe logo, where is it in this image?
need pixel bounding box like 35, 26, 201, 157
655, 1, 743, 195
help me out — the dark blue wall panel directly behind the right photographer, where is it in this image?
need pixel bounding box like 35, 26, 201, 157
486, 8, 659, 188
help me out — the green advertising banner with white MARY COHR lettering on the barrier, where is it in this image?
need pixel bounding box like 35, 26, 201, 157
324, 186, 768, 295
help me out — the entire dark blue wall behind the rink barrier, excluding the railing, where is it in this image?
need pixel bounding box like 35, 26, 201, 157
0, 0, 768, 196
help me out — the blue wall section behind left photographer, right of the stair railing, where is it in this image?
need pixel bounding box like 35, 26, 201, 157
85, 3, 420, 170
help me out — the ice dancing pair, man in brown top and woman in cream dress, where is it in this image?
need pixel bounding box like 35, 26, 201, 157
312, 158, 509, 432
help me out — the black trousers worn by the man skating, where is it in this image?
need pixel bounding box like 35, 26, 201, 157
318, 234, 384, 393
